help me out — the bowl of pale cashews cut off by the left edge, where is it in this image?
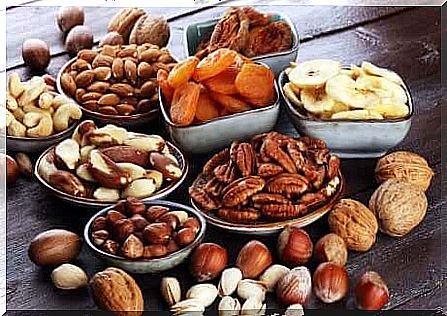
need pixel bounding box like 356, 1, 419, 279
6, 73, 82, 153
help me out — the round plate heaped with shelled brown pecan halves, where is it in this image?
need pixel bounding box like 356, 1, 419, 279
189, 132, 344, 235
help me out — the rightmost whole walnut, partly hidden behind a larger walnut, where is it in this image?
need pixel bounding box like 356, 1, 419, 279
376, 151, 434, 191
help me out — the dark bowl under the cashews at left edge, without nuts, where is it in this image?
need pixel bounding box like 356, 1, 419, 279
6, 121, 79, 154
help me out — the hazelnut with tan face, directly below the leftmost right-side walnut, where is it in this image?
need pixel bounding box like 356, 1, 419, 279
314, 233, 348, 266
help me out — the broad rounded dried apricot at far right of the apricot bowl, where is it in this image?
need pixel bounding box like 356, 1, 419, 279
235, 64, 275, 99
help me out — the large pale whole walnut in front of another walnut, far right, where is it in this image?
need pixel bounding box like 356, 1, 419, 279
369, 179, 427, 237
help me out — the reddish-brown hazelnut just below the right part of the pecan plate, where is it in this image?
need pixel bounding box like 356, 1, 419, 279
278, 226, 313, 266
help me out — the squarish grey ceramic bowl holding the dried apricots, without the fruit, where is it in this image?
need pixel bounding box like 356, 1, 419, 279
160, 82, 280, 154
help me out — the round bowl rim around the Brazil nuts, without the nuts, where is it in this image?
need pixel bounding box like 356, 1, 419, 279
34, 133, 189, 209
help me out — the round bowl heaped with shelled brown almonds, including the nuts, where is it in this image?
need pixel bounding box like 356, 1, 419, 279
57, 44, 176, 127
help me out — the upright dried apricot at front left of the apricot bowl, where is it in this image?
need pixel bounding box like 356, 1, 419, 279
170, 82, 200, 126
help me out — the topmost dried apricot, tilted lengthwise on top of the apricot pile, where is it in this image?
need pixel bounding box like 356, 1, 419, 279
193, 48, 238, 81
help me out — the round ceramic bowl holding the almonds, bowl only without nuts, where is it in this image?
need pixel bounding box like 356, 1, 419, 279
56, 57, 159, 128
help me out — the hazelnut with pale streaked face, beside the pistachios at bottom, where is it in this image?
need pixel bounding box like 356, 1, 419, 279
276, 267, 312, 305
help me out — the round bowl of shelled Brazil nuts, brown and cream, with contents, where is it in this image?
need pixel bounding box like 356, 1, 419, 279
34, 120, 188, 208
